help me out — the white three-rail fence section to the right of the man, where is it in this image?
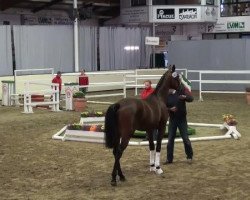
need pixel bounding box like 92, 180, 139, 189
188, 70, 250, 101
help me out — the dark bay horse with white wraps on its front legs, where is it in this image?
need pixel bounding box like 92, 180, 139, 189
104, 66, 180, 186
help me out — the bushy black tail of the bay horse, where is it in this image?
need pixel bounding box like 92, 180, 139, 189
104, 103, 120, 148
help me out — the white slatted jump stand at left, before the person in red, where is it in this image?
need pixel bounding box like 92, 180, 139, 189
23, 81, 60, 113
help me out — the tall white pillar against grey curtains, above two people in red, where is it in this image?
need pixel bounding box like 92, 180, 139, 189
74, 0, 79, 72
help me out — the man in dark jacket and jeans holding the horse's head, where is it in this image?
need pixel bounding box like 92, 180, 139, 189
165, 85, 193, 164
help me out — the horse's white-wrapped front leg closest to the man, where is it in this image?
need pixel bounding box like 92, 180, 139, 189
155, 123, 166, 174
